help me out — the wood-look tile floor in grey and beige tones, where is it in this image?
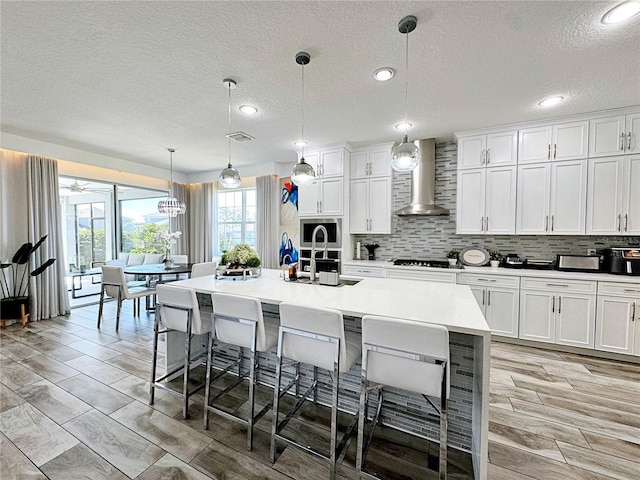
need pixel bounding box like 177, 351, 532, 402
0, 302, 640, 480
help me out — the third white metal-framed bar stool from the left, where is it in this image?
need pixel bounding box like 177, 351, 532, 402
270, 302, 362, 480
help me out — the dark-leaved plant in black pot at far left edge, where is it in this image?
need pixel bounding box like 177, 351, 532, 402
0, 235, 56, 326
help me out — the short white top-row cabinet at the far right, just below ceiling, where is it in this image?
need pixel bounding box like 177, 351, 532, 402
589, 113, 640, 157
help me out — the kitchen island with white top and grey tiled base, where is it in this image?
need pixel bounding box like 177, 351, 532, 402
167, 269, 491, 479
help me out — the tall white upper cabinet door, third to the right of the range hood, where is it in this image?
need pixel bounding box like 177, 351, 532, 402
516, 163, 551, 235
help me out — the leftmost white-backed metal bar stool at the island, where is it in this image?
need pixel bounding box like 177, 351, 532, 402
149, 284, 212, 419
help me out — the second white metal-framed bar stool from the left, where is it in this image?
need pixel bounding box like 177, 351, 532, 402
204, 293, 278, 450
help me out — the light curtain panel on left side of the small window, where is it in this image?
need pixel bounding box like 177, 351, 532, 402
187, 182, 216, 263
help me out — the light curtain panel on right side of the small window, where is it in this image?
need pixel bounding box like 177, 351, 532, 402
256, 175, 280, 268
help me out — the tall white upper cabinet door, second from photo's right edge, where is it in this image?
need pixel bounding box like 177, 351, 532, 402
587, 157, 628, 235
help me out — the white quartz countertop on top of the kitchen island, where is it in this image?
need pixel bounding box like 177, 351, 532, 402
171, 269, 490, 336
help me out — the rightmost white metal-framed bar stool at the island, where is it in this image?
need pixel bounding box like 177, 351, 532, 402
356, 315, 450, 479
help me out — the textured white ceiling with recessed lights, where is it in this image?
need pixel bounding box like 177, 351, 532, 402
0, 0, 640, 173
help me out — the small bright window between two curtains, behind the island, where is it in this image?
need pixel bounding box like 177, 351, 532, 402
215, 188, 256, 255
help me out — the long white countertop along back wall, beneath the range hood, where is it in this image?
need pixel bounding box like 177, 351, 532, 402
343, 260, 640, 285
